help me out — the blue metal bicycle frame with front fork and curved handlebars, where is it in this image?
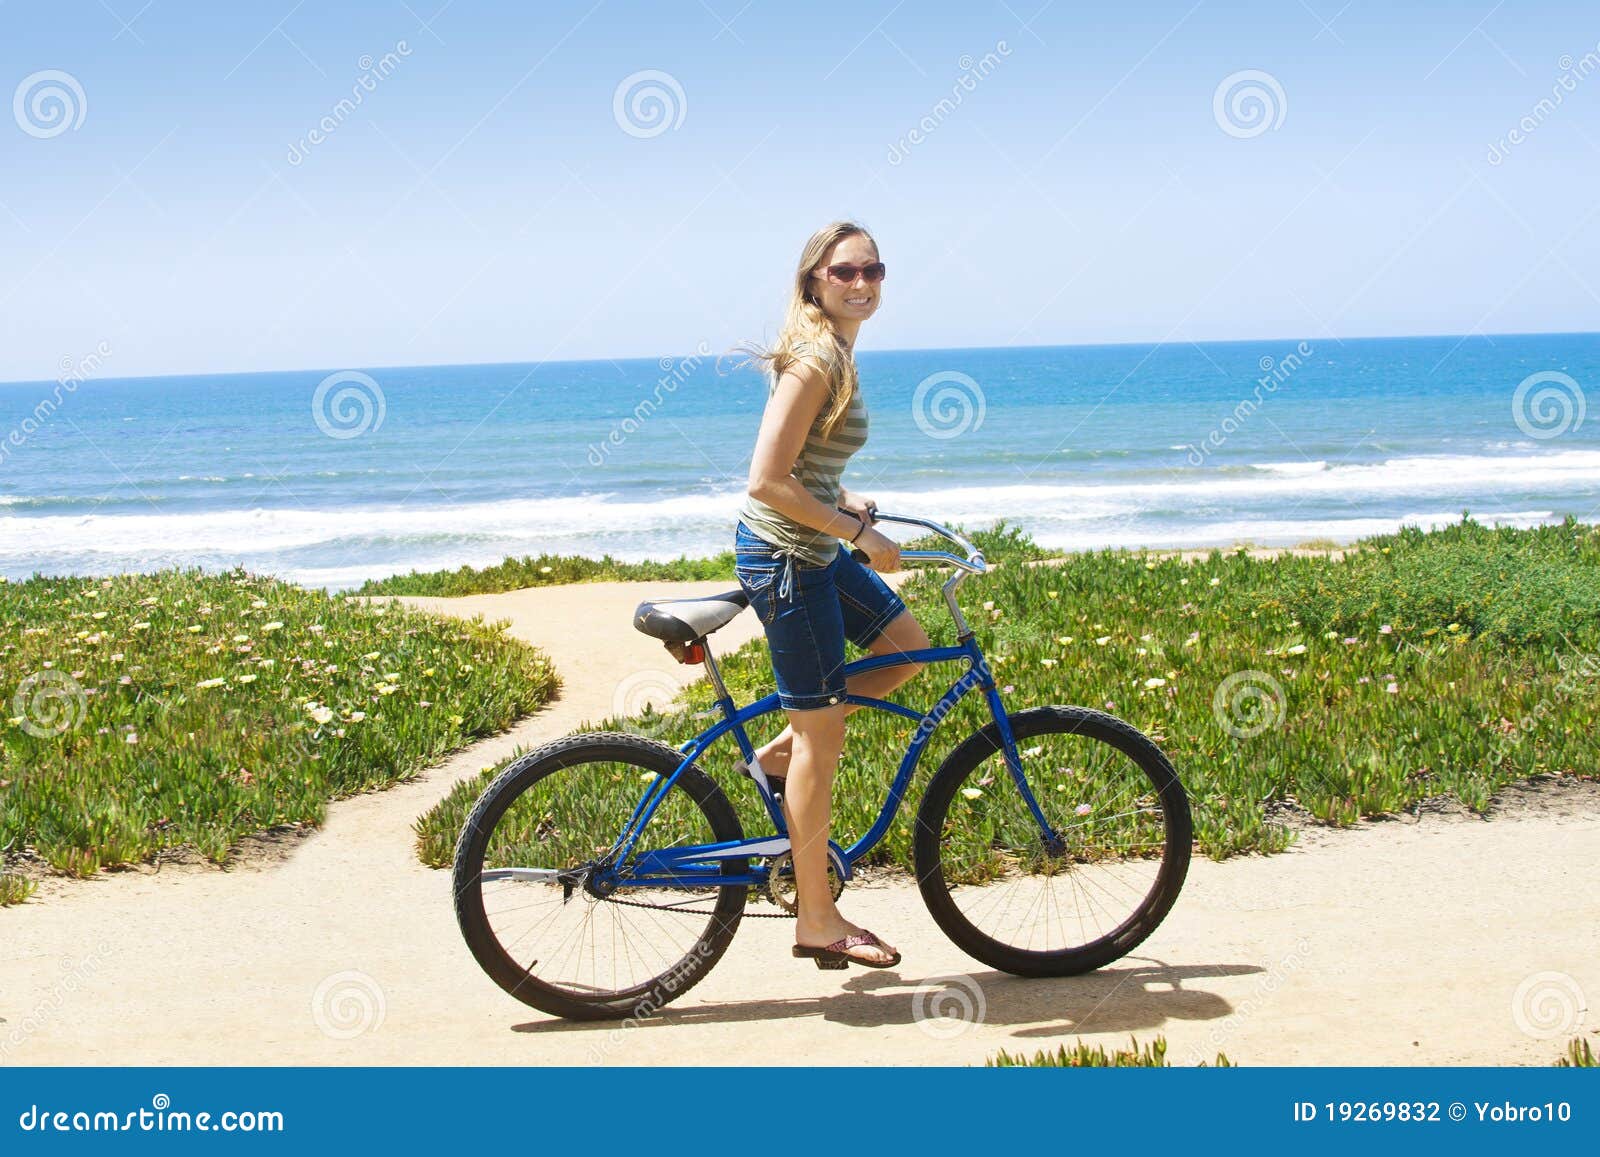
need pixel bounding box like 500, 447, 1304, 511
600, 514, 1059, 888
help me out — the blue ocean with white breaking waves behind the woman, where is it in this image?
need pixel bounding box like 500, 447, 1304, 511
0, 334, 1600, 589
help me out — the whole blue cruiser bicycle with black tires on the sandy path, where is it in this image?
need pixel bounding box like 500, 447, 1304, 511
454, 512, 1192, 1019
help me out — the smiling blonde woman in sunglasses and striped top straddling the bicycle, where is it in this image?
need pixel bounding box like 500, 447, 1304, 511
734, 221, 930, 968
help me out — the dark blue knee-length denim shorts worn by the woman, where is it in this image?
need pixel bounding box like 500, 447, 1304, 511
733, 518, 906, 711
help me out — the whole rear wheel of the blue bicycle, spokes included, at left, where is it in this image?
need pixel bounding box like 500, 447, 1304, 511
454, 731, 746, 1019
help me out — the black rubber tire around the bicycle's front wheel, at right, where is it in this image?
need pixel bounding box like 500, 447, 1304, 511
914, 706, 1194, 976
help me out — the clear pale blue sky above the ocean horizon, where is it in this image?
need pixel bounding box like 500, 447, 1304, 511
0, 0, 1600, 381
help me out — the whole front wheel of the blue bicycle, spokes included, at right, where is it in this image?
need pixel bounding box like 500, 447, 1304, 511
914, 707, 1194, 976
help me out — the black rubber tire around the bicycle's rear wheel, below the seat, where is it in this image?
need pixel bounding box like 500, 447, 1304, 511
451, 731, 747, 1021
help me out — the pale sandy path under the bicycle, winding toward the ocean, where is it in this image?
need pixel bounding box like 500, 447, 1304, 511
0, 576, 1600, 1064
